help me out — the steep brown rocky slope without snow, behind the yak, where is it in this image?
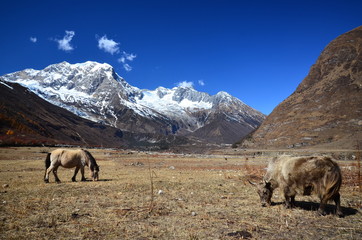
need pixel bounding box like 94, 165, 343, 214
243, 26, 362, 149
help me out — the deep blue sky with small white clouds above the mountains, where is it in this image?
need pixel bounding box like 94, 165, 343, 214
0, 0, 362, 114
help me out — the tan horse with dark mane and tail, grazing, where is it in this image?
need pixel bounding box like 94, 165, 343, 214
44, 149, 99, 183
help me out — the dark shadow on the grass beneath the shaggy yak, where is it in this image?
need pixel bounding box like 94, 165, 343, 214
272, 201, 358, 217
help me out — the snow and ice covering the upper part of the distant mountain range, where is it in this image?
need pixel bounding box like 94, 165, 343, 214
3, 61, 263, 137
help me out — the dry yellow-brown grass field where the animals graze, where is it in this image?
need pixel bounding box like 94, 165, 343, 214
0, 148, 362, 239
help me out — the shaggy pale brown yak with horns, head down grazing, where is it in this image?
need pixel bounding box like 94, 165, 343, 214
252, 156, 343, 217
